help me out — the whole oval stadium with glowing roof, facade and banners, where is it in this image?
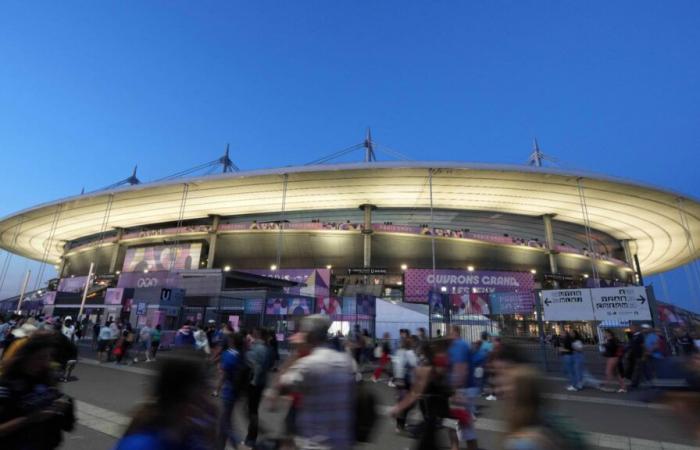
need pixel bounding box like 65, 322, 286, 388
0, 144, 700, 342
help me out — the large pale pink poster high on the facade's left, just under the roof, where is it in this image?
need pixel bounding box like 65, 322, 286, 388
122, 242, 202, 272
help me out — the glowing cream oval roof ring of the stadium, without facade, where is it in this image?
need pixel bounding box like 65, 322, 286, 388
0, 162, 700, 273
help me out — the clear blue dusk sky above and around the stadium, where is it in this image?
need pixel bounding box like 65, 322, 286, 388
0, 0, 700, 311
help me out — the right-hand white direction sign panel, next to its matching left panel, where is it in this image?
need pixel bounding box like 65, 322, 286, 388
591, 286, 651, 320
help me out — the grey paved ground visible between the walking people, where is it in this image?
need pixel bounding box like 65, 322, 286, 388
57, 346, 698, 450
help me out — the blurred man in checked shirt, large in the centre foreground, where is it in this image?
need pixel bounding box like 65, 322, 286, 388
271, 314, 356, 450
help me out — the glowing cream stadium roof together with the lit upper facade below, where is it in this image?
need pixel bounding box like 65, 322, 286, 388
0, 162, 700, 279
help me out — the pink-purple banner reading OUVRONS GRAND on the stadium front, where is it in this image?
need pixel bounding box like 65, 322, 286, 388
404, 269, 534, 303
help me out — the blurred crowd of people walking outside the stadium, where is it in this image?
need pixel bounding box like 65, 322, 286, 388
0, 315, 700, 450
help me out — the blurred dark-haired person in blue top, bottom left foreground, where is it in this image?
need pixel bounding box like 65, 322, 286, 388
114, 350, 216, 450
